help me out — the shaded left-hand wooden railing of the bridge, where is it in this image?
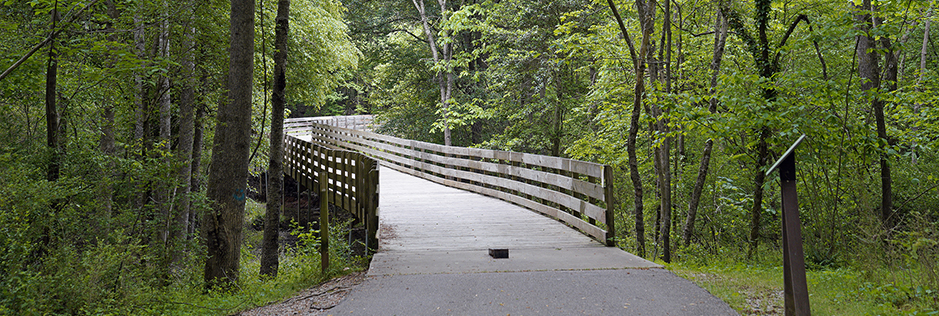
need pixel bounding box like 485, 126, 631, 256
284, 121, 379, 249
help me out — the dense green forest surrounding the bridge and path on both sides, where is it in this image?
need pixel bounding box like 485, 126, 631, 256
0, 0, 939, 314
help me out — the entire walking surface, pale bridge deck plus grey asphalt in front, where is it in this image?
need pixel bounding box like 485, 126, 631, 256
328, 167, 736, 315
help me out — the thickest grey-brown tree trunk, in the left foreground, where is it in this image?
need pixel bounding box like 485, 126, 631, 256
202, 0, 254, 287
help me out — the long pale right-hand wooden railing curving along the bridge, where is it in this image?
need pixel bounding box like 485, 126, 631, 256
298, 122, 615, 246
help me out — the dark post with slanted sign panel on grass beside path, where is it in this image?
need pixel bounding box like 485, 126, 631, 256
766, 134, 812, 316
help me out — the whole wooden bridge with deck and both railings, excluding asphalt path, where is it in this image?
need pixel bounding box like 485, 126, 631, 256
285, 116, 656, 274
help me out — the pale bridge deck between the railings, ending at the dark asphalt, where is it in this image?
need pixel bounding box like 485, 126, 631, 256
369, 167, 658, 275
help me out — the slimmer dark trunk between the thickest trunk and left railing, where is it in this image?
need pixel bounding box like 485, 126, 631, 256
261, 0, 290, 277
